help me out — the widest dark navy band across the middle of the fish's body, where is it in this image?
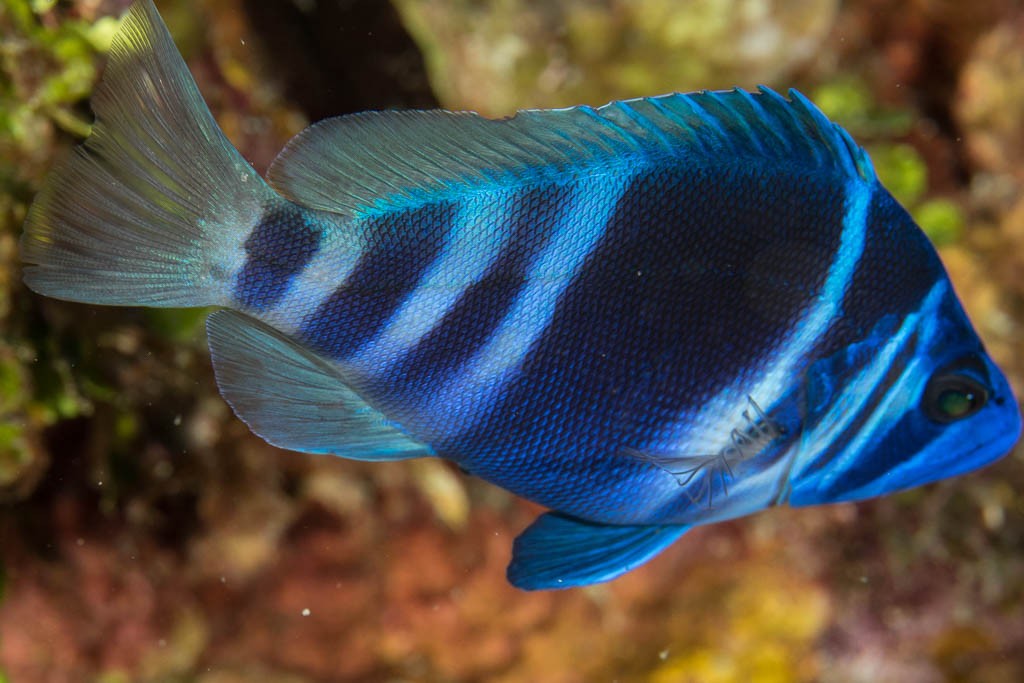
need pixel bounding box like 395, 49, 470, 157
441, 169, 844, 516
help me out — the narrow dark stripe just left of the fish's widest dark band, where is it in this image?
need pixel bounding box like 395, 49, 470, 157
392, 184, 572, 386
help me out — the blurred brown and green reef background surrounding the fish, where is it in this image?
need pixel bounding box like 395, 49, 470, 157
0, 0, 1024, 683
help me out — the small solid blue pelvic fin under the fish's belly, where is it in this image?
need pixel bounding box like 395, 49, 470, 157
508, 512, 690, 591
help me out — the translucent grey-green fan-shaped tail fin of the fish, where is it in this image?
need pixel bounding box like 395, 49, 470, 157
22, 0, 281, 306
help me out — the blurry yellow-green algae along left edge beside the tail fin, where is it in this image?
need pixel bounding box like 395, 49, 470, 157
0, 0, 112, 498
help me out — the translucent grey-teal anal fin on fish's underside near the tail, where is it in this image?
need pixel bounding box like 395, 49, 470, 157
207, 310, 433, 461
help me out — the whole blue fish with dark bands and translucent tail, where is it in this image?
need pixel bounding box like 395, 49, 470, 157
22, 0, 1021, 589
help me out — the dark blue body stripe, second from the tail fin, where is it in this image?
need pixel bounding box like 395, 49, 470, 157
300, 203, 457, 358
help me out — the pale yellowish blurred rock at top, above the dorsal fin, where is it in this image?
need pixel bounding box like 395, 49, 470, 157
395, 0, 838, 116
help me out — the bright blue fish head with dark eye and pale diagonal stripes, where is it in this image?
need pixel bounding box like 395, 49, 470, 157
788, 276, 1021, 505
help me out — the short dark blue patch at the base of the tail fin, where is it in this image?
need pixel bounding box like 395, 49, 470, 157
234, 202, 322, 311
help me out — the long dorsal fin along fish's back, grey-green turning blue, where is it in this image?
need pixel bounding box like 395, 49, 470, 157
268, 87, 874, 214
